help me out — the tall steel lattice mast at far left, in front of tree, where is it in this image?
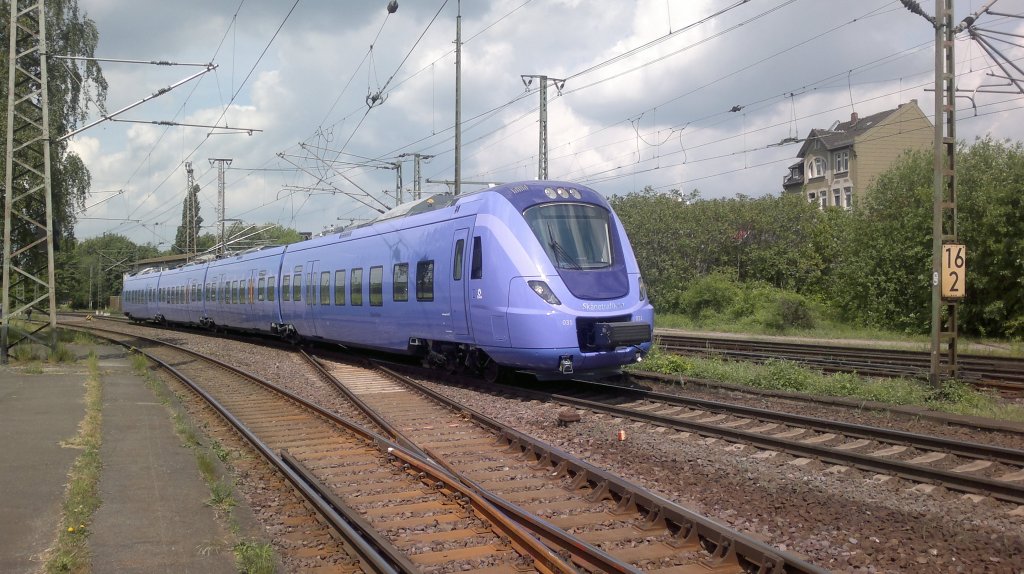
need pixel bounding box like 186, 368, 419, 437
0, 0, 57, 362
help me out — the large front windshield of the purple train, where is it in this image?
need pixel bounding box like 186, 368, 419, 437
522, 203, 611, 270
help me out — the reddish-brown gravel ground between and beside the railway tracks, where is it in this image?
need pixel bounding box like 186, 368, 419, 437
105, 323, 1024, 574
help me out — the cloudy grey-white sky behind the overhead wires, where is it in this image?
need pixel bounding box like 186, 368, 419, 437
72, 0, 1024, 249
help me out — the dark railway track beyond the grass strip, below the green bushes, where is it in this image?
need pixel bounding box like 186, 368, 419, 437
655, 332, 1024, 395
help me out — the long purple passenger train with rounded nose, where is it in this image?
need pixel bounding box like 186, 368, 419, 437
122, 181, 654, 379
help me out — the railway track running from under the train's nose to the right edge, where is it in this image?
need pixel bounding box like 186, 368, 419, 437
415, 374, 1024, 504
